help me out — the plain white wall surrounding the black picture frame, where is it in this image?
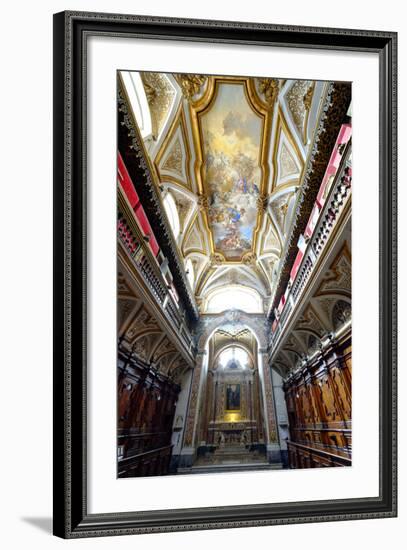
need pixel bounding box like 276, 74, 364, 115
0, 0, 407, 550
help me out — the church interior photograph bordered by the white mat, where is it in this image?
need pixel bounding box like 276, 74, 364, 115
117, 71, 352, 477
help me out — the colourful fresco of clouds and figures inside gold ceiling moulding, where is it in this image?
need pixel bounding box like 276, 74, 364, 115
201, 84, 262, 260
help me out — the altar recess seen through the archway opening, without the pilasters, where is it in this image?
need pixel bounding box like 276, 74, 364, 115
195, 327, 267, 467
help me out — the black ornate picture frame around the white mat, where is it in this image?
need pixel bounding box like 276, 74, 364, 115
54, 12, 397, 538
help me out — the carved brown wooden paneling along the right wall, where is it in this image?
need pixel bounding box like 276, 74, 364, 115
284, 334, 352, 468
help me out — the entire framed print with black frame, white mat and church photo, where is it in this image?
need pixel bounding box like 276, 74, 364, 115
54, 12, 397, 538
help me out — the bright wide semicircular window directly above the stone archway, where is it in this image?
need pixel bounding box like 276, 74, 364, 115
206, 285, 263, 313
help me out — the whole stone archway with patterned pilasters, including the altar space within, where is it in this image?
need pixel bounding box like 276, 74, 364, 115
179, 310, 281, 470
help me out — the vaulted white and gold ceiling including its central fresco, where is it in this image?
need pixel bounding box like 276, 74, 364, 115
121, 72, 326, 312
